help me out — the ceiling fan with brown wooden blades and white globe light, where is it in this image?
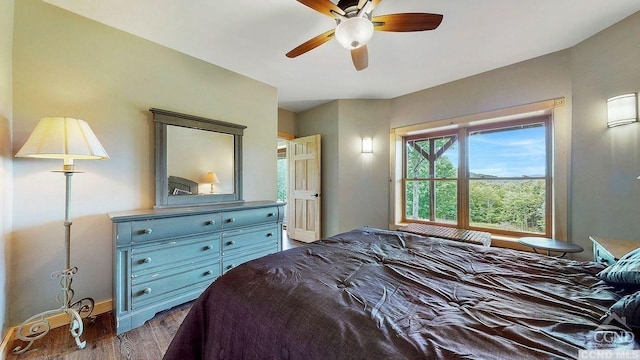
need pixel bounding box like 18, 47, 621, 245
287, 0, 442, 71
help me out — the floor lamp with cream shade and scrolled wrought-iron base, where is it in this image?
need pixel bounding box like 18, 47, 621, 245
13, 117, 109, 354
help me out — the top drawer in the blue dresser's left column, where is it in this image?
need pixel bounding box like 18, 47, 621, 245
131, 213, 221, 242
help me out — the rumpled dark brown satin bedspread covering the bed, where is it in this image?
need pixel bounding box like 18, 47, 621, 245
165, 228, 639, 359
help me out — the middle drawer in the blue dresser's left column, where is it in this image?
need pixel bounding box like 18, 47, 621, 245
131, 234, 220, 277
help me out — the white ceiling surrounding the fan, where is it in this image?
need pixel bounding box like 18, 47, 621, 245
45, 0, 640, 112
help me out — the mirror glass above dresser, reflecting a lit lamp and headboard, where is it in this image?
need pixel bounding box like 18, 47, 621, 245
166, 126, 235, 196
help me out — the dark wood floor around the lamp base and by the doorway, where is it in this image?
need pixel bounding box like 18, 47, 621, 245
6, 233, 304, 360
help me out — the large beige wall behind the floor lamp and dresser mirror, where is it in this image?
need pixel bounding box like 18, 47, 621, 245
11, 0, 277, 324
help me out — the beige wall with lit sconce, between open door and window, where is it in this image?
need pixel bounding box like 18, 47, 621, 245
296, 100, 391, 237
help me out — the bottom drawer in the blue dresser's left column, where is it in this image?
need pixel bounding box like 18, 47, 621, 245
131, 261, 220, 309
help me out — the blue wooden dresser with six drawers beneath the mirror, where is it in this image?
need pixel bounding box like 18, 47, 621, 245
109, 201, 284, 334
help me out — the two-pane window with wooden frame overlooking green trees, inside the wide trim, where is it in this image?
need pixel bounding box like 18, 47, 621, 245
403, 116, 552, 236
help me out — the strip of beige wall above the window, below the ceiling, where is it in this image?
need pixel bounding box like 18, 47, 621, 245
391, 50, 571, 129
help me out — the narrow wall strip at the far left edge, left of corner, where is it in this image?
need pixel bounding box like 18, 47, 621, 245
0, 0, 14, 338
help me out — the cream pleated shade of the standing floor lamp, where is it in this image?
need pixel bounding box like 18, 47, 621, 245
16, 117, 109, 165
